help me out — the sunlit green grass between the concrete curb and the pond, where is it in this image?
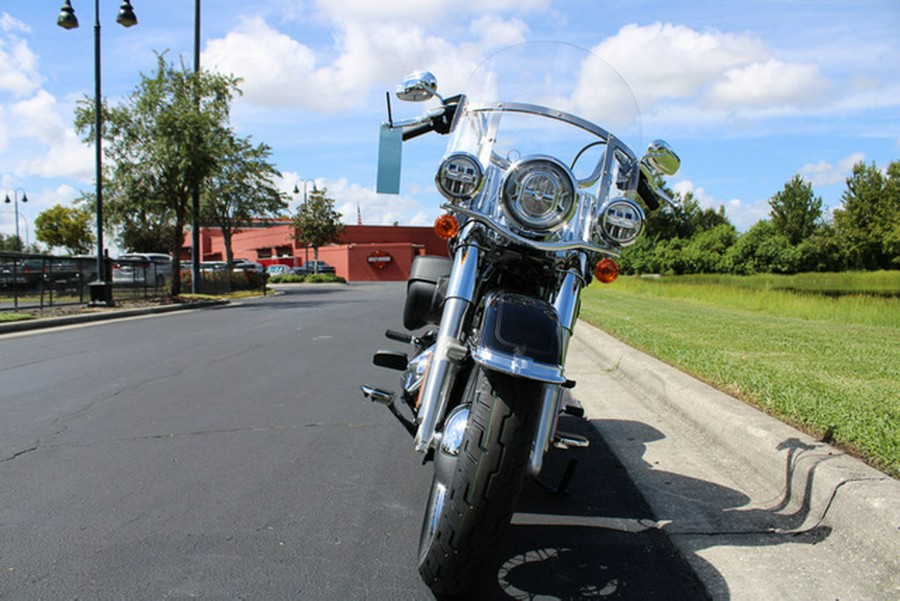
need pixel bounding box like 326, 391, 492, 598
582, 277, 900, 477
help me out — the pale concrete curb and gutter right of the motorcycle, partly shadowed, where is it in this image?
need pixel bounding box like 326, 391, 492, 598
567, 322, 900, 600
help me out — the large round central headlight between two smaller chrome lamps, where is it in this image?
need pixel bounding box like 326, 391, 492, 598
500, 157, 577, 235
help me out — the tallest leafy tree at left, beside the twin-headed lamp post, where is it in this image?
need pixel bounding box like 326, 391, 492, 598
75, 54, 240, 295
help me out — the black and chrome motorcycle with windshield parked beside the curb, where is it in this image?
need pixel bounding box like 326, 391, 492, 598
362, 43, 680, 596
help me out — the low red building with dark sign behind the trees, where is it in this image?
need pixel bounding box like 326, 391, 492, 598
183, 221, 448, 282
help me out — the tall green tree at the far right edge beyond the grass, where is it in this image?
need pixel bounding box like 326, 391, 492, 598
834, 161, 900, 269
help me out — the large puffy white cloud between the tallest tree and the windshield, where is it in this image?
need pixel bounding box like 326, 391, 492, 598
202, 17, 527, 113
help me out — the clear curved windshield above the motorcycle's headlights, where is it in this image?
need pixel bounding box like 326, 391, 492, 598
450, 42, 641, 182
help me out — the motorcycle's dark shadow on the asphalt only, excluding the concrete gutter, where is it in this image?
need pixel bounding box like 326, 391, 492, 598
468, 419, 708, 600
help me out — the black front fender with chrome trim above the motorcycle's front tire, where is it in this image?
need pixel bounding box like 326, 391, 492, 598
472, 292, 566, 384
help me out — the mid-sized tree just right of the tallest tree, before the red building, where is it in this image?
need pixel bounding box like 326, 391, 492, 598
201, 132, 287, 269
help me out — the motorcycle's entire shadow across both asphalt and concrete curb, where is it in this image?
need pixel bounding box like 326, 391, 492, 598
464, 418, 831, 599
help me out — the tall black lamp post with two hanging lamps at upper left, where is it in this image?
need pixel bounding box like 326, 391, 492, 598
56, 0, 137, 306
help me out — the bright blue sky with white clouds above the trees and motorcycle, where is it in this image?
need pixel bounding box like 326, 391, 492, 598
0, 0, 900, 251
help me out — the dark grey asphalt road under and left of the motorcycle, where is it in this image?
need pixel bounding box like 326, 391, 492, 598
0, 284, 703, 599
